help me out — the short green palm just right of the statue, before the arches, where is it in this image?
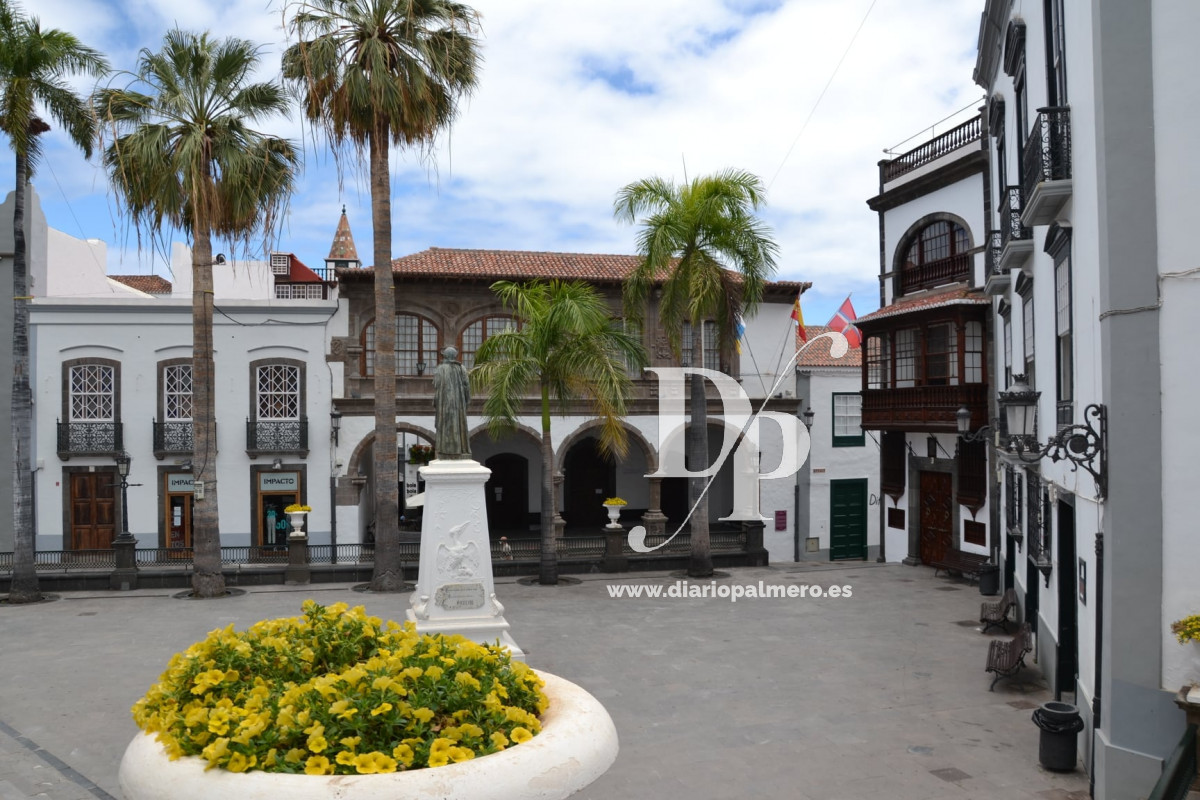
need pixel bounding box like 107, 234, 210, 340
470, 281, 647, 585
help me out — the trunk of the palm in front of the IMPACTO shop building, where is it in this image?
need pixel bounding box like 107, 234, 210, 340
192, 213, 226, 597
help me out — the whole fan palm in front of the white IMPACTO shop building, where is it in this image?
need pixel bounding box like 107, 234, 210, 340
95, 29, 299, 597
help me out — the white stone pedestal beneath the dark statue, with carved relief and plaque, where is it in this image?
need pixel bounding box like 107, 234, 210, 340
408, 459, 524, 661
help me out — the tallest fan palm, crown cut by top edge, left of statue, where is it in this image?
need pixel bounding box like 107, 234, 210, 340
283, 0, 480, 591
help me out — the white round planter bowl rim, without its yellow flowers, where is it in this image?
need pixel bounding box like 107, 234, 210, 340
119, 672, 617, 800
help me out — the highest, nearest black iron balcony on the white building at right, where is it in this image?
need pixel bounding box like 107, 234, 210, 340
1021, 107, 1072, 225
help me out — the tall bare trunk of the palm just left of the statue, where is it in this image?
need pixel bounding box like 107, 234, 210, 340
370, 126, 404, 591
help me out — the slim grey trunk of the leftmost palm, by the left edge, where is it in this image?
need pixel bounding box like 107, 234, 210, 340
8, 152, 42, 603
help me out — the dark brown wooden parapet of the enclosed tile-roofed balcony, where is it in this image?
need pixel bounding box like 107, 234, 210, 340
863, 384, 988, 433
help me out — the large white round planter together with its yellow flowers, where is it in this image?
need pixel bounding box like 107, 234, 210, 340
119, 600, 617, 800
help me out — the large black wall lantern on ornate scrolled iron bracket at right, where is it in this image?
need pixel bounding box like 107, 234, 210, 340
998, 375, 1109, 500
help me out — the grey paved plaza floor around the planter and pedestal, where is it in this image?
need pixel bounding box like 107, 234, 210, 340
0, 563, 1087, 800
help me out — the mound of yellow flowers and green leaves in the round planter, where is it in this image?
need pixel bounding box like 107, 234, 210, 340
133, 600, 547, 775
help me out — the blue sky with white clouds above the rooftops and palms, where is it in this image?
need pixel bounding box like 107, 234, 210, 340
7, 0, 983, 324
